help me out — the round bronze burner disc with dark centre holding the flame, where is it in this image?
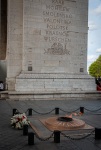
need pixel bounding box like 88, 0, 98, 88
43, 116, 85, 131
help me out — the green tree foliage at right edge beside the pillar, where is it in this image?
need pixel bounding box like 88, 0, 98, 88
89, 55, 101, 78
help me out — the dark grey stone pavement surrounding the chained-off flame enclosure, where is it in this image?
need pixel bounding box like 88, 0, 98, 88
0, 100, 101, 150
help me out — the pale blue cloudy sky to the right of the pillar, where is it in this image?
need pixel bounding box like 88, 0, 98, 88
87, 0, 101, 71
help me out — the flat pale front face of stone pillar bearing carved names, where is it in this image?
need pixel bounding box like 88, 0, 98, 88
23, 0, 87, 73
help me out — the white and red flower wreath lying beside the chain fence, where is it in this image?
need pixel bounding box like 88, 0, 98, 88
11, 113, 30, 129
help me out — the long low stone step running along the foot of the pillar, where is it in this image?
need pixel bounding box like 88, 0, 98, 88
0, 91, 101, 100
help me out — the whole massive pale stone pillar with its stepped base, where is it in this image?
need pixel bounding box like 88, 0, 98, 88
7, 0, 96, 99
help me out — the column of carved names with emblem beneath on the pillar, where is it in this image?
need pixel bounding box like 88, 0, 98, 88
43, 0, 72, 55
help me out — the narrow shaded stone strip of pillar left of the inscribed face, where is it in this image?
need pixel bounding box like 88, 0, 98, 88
7, 0, 23, 90
